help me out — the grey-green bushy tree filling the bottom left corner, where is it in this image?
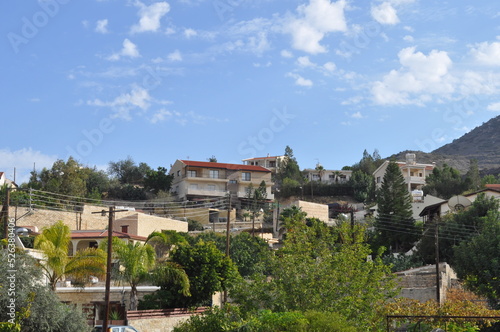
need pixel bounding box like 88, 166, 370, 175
0, 250, 90, 332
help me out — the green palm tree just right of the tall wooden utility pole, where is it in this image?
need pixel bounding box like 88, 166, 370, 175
107, 237, 156, 310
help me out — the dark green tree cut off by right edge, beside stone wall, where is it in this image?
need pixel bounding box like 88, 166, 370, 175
453, 209, 500, 309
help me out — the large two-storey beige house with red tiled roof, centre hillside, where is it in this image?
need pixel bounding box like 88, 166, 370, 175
170, 160, 274, 201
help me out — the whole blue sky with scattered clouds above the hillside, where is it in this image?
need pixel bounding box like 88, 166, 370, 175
0, 0, 500, 182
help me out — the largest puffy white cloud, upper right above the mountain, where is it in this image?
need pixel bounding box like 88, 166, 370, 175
371, 47, 454, 105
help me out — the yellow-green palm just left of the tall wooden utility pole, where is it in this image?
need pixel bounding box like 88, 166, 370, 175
34, 221, 106, 290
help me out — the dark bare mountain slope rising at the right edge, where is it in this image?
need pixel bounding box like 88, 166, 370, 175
388, 116, 500, 175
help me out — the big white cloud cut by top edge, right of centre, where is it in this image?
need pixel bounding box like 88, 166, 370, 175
285, 0, 347, 54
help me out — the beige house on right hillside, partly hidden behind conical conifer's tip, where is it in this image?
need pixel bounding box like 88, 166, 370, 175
373, 153, 436, 192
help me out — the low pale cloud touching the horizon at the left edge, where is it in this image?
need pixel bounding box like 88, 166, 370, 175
0, 148, 57, 184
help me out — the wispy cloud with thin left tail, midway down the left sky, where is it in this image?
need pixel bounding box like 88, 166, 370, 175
87, 87, 152, 120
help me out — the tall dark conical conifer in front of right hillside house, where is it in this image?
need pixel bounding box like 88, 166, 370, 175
374, 162, 420, 252
